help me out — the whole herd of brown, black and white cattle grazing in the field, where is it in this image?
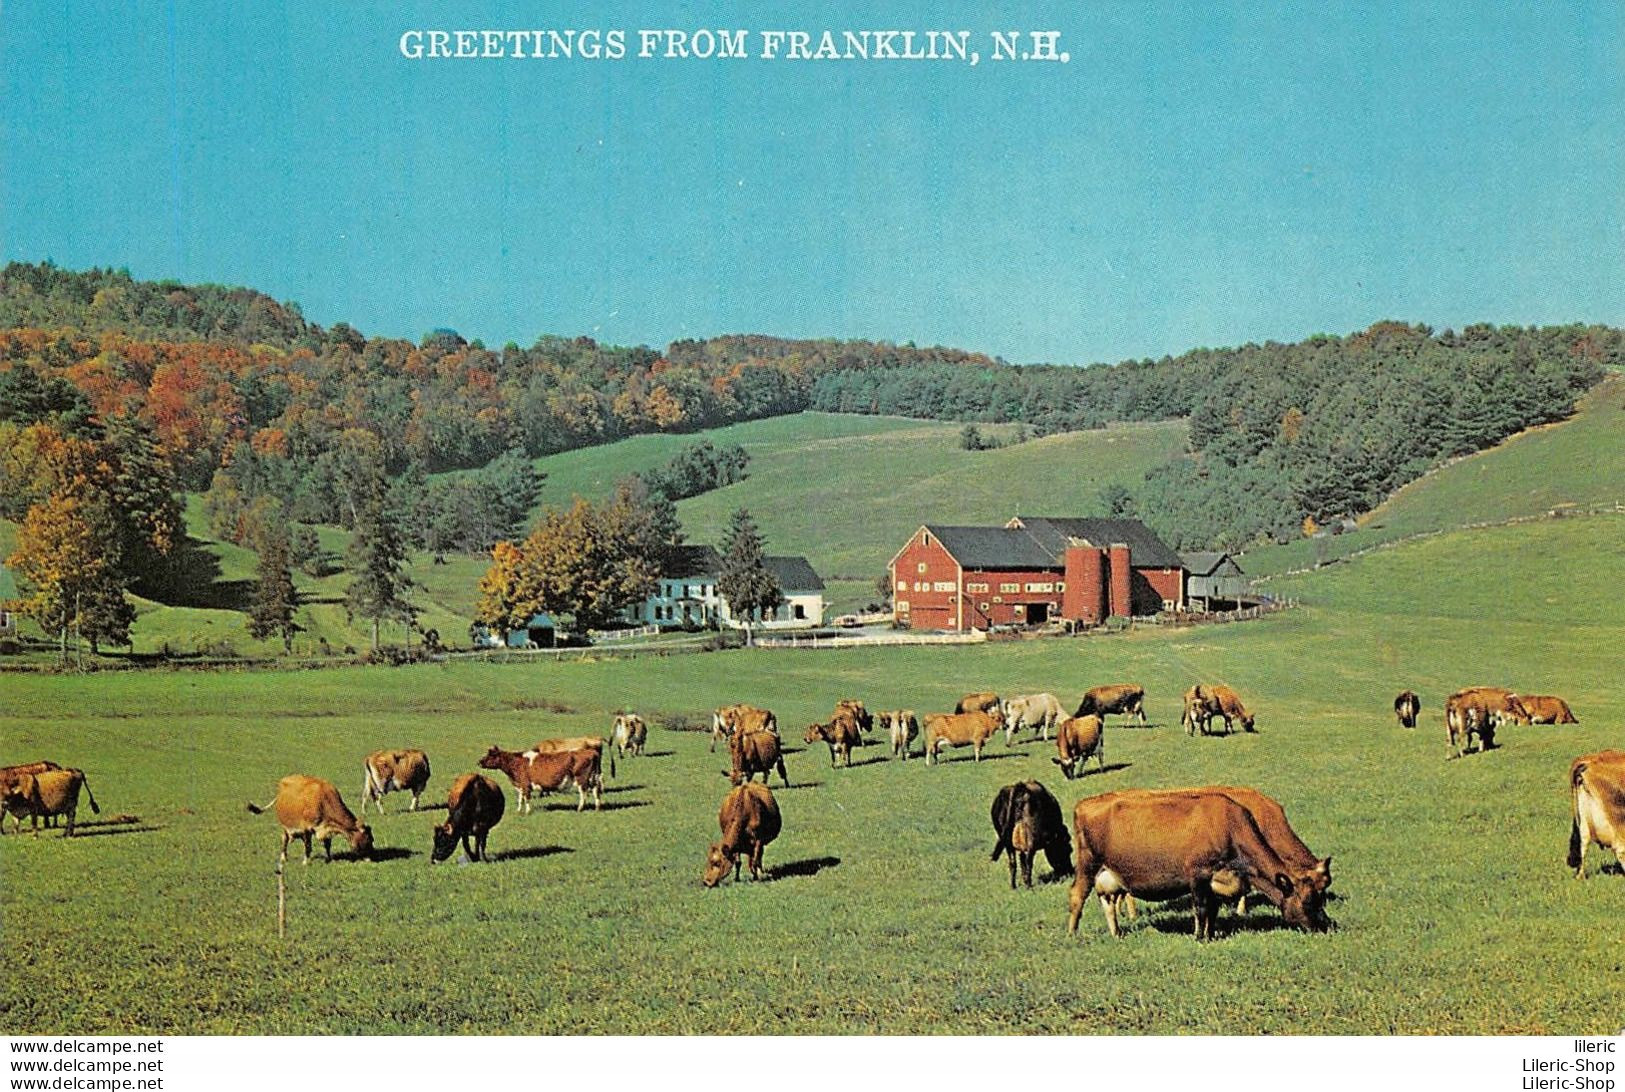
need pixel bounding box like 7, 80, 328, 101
0, 684, 1625, 939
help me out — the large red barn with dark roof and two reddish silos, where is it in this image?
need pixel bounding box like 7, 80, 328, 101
891, 515, 1185, 631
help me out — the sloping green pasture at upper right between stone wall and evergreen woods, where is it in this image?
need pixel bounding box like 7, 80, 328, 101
1242, 375, 1625, 575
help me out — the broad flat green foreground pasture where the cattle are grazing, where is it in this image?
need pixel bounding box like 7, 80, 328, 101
0, 518, 1625, 1035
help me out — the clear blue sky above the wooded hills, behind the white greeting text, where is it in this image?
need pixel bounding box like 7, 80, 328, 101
0, 0, 1625, 362
